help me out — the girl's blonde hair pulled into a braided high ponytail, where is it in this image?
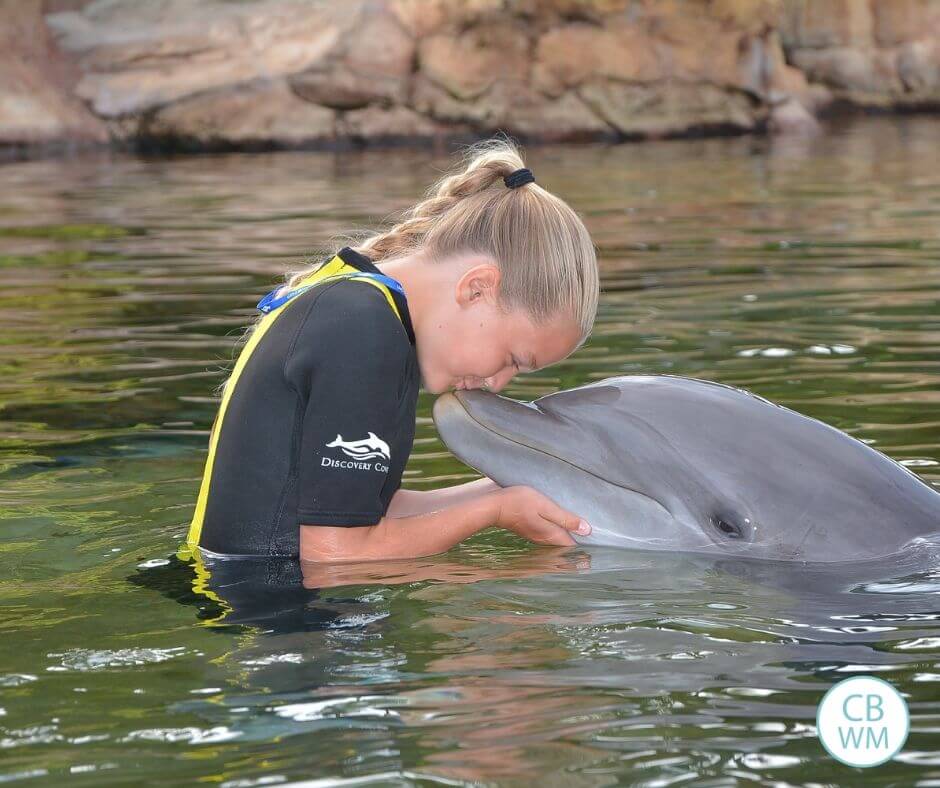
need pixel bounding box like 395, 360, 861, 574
291, 137, 600, 346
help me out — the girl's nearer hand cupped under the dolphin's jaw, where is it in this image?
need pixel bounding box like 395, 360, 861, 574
494, 485, 591, 547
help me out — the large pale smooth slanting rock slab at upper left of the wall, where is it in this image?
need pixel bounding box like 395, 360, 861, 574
47, 0, 361, 117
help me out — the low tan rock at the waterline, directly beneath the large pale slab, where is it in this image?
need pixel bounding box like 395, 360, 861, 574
145, 79, 336, 146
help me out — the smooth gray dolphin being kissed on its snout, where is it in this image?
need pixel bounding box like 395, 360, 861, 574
433, 375, 940, 562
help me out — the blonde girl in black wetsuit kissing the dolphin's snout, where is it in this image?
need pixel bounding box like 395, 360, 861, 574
187, 139, 598, 561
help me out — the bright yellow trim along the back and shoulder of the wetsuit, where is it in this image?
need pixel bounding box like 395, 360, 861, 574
180, 255, 401, 558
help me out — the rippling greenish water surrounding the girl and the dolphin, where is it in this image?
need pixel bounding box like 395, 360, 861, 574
0, 118, 940, 788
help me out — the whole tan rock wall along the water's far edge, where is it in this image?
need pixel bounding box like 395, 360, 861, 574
0, 0, 940, 155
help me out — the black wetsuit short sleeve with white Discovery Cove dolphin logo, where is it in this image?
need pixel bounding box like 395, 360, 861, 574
286, 282, 410, 526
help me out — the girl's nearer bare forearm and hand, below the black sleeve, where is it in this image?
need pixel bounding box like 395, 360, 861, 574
300, 485, 590, 562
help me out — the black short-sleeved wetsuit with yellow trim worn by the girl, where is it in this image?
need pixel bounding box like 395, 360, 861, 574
187, 247, 420, 556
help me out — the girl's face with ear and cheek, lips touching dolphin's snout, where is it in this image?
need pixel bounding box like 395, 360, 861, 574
416, 266, 581, 394
